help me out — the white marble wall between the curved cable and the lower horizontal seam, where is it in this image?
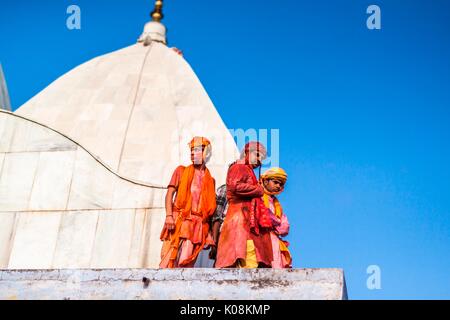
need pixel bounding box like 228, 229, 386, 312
0, 112, 165, 211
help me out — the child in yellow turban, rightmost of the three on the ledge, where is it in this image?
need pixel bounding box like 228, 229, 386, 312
261, 168, 292, 269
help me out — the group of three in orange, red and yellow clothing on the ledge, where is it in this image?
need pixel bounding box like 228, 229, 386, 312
160, 137, 292, 268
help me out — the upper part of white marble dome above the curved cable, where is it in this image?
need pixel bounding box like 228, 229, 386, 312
16, 40, 237, 185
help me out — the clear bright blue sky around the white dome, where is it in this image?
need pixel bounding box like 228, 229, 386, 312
0, 0, 450, 299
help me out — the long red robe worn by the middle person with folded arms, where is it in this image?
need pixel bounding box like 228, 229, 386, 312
215, 160, 273, 268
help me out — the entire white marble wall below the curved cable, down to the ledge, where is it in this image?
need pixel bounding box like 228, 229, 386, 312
0, 112, 165, 269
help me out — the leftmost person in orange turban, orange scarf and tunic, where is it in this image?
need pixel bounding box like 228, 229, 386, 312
159, 137, 216, 268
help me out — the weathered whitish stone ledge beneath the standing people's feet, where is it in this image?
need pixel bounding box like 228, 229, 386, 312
0, 268, 347, 300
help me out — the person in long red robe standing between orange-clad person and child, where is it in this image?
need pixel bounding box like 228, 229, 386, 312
215, 142, 273, 268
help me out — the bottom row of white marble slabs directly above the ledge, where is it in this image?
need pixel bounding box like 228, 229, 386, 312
0, 209, 164, 269
